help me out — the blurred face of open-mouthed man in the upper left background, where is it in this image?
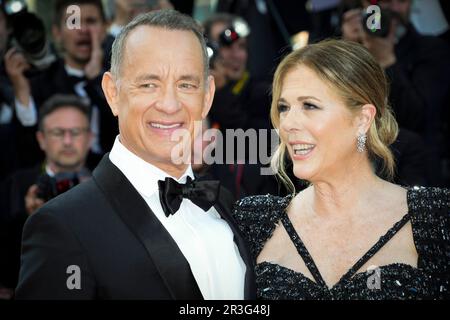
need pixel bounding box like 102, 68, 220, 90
53, 4, 105, 64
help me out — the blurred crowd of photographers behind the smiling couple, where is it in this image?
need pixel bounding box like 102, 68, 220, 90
0, 0, 450, 299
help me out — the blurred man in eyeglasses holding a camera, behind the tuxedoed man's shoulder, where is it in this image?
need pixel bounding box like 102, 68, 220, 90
0, 95, 93, 288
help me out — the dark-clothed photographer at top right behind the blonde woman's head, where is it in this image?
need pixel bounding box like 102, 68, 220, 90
341, 0, 450, 186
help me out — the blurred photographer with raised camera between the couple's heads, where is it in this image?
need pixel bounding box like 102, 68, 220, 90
204, 13, 271, 160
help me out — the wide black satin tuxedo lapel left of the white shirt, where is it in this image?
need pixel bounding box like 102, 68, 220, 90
93, 153, 203, 299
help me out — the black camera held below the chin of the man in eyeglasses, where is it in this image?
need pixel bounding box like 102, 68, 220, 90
36, 172, 80, 202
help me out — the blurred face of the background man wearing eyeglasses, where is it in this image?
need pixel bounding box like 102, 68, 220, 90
37, 106, 92, 172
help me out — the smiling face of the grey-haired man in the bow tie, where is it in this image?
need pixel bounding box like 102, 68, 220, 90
102, 26, 214, 173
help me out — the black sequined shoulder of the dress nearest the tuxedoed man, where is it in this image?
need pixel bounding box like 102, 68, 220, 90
233, 194, 292, 257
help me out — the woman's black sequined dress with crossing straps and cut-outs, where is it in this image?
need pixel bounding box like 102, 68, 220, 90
234, 187, 450, 300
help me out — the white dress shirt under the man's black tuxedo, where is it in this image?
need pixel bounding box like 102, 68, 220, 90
109, 136, 246, 300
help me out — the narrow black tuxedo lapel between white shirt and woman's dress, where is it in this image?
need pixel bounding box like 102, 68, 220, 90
214, 188, 256, 300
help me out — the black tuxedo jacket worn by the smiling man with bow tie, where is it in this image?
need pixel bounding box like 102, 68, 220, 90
15, 154, 255, 300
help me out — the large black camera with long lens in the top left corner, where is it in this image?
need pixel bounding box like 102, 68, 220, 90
0, 0, 56, 70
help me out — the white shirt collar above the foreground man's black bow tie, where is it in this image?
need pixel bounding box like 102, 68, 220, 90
109, 135, 195, 197
